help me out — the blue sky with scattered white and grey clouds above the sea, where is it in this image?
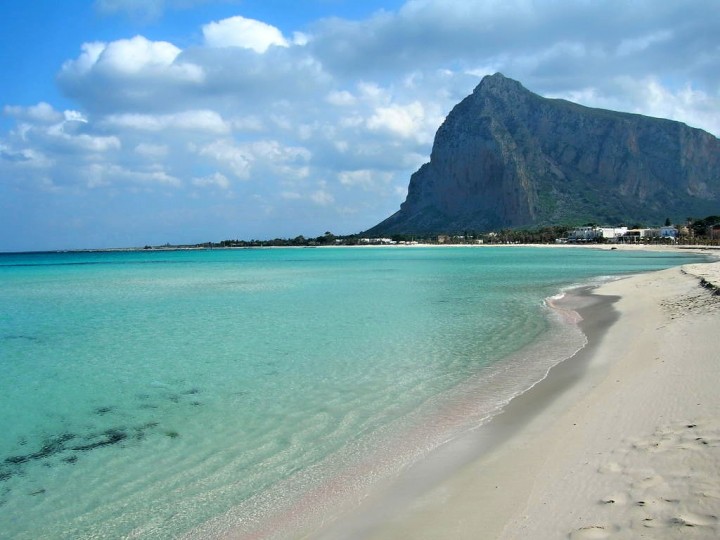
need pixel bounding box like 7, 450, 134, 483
0, 0, 720, 252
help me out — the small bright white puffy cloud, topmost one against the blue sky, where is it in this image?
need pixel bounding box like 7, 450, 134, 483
202, 15, 289, 53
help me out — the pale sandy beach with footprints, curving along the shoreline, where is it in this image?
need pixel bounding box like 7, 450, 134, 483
330, 251, 720, 540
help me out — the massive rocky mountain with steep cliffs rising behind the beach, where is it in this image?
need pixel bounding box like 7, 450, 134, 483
366, 73, 720, 235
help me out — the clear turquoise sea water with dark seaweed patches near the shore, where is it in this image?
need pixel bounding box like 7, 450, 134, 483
0, 248, 702, 539
